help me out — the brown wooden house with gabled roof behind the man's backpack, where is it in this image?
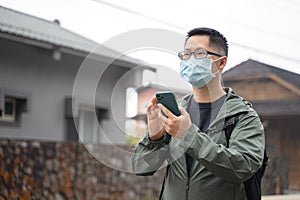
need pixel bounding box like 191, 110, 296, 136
223, 59, 300, 192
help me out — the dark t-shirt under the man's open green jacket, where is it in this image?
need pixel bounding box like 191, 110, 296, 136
186, 95, 226, 175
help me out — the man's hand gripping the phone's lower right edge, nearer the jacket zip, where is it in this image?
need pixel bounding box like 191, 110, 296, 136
157, 104, 192, 138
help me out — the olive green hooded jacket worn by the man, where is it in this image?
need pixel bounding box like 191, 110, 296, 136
132, 88, 265, 200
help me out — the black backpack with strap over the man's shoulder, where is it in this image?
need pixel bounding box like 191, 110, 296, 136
222, 115, 269, 200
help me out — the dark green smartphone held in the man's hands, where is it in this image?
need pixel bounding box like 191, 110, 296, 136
155, 91, 181, 116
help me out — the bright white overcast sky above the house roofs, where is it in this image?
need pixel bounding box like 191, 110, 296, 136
0, 0, 300, 79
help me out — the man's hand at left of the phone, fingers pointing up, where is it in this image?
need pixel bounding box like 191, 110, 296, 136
147, 96, 165, 140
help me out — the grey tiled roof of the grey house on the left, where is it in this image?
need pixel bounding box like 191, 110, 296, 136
0, 6, 146, 63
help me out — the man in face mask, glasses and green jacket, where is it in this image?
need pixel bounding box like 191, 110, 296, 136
132, 28, 265, 200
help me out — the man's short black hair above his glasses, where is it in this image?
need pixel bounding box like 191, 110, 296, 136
186, 27, 228, 56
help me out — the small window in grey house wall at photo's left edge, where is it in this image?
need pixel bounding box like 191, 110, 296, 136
0, 98, 16, 122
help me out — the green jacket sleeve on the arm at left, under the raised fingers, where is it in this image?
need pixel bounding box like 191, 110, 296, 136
131, 133, 169, 176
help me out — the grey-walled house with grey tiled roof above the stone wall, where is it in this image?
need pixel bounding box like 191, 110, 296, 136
0, 7, 155, 144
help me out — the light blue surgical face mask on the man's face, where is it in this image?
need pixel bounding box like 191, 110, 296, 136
180, 56, 219, 88
